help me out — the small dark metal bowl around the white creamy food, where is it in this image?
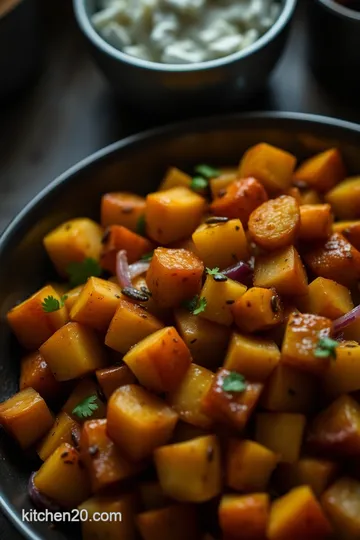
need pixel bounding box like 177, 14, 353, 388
73, 0, 297, 111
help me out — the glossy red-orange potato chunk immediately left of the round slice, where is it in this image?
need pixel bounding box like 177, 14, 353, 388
210, 178, 268, 227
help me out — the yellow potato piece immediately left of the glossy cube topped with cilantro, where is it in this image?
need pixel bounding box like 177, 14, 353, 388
167, 364, 215, 429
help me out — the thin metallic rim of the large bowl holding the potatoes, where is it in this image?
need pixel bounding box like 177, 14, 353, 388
0, 111, 360, 540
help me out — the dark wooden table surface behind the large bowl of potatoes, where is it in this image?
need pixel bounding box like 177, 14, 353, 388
0, 0, 360, 540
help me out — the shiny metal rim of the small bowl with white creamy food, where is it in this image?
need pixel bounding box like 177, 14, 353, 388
73, 0, 298, 73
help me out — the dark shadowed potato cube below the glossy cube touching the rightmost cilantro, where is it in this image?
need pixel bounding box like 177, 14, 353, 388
260, 362, 318, 414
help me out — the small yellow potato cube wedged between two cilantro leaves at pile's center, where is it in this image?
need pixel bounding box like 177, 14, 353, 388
200, 275, 246, 326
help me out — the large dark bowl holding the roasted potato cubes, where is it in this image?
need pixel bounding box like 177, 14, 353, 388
0, 113, 360, 540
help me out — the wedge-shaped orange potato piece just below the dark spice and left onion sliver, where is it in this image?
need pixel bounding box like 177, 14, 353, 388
105, 298, 163, 354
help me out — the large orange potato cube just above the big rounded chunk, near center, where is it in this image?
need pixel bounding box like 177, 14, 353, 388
123, 326, 192, 392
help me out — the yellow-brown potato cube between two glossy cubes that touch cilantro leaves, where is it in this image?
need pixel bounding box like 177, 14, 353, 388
224, 332, 280, 382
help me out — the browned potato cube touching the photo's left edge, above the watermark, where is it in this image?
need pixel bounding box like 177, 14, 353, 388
0, 388, 54, 448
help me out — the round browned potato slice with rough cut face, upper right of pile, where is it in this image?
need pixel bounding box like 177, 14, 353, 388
249, 195, 300, 251
